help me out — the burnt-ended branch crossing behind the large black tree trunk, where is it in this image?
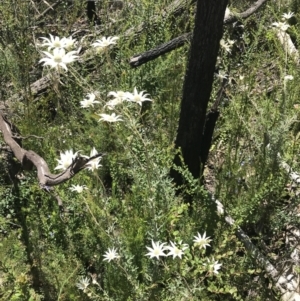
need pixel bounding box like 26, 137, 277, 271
129, 0, 268, 67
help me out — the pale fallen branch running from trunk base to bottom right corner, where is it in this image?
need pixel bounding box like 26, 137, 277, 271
215, 200, 300, 301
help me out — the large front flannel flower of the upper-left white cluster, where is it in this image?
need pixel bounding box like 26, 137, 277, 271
39, 48, 78, 71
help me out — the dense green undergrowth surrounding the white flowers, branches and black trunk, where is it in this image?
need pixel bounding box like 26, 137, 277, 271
0, 0, 300, 301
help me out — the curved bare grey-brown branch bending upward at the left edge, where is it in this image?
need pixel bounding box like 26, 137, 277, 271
0, 112, 102, 188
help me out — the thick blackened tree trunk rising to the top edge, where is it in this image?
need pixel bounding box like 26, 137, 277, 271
171, 0, 228, 185
